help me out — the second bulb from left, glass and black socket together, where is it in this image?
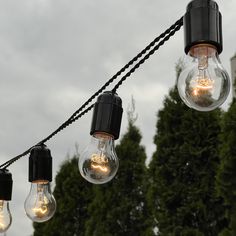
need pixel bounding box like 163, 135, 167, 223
25, 144, 56, 222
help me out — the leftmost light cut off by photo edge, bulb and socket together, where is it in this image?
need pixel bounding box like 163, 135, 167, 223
0, 169, 13, 233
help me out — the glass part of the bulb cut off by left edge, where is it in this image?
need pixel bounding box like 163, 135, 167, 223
0, 200, 12, 233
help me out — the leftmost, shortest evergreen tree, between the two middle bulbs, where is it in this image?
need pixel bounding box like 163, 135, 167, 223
34, 157, 92, 236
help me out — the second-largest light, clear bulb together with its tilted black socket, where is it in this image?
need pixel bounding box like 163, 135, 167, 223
79, 91, 123, 184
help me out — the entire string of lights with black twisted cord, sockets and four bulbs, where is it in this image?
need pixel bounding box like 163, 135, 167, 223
0, 0, 230, 233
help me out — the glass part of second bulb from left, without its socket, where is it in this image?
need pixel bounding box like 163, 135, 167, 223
25, 181, 56, 222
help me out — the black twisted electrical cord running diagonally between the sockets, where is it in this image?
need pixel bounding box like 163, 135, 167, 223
0, 17, 183, 169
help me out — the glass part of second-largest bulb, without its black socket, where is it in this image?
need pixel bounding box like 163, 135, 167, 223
79, 133, 119, 184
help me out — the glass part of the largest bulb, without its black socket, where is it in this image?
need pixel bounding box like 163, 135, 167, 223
177, 44, 230, 111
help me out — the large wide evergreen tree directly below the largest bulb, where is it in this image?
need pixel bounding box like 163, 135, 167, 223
147, 63, 225, 236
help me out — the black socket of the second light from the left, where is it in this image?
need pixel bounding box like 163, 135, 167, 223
29, 145, 52, 182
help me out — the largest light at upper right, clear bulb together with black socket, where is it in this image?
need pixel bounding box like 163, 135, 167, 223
177, 0, 231, 111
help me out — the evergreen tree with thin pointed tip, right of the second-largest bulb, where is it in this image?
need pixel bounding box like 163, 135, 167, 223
85, 112, 147, 236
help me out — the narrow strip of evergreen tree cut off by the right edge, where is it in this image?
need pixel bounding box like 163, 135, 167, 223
217, 95, 236, 236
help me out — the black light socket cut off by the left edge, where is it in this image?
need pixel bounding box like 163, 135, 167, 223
0, 169, 13, 201
